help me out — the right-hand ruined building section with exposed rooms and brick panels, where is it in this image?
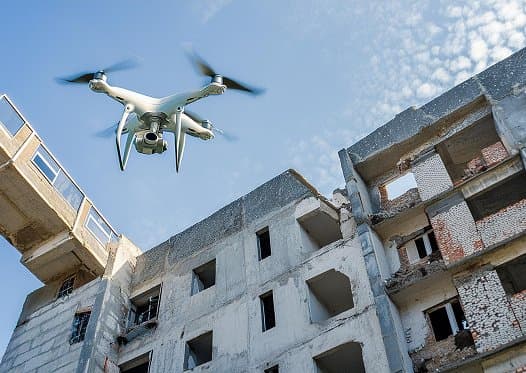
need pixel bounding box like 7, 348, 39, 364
339, 50, 526, 372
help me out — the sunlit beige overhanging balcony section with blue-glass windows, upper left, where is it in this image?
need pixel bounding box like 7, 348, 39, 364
0, 95, 117, 283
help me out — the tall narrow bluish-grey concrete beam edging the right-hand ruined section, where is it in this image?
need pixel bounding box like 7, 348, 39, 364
338, 149, 413, 373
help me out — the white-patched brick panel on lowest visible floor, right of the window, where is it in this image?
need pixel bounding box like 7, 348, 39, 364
455, 269, 522, 353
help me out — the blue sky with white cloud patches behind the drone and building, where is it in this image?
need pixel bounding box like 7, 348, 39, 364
0, 0, 526, 354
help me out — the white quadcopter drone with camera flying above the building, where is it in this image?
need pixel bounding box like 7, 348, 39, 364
57, 53, 263, 172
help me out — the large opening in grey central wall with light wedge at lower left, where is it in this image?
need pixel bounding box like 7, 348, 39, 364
307, 269, 354, 322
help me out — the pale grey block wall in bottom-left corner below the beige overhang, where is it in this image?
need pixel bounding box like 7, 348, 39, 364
0, 279, 100, 373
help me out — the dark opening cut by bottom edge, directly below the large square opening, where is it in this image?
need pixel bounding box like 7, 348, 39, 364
313, 342, 365, 373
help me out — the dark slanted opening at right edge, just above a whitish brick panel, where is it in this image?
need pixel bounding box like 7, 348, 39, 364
466, 172, 526, 221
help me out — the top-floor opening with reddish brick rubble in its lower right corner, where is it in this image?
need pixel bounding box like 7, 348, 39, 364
436, 115, 508, 182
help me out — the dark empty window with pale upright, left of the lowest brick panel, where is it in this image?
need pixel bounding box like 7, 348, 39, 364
427, 299, 468, 341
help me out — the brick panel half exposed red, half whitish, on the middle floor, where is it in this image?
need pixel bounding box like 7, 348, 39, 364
431, 201, 484, 264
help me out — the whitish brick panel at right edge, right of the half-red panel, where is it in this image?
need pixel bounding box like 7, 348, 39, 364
476, 199, 526, 246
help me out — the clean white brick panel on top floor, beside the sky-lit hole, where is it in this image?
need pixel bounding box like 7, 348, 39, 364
412, 153, 453, 201
